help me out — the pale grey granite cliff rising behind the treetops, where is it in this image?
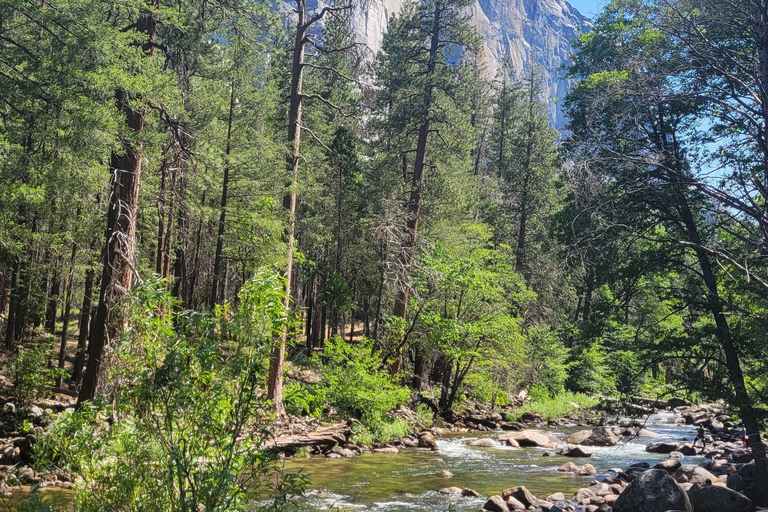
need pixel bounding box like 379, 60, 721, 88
355, 0, 592, 127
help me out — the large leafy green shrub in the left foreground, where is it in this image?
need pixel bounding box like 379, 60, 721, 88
30, 269, 304, 512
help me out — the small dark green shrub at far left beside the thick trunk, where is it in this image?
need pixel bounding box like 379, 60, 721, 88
11, 342, 66, 413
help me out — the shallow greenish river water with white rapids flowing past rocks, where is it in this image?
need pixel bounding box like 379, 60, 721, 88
285, 413, 696, 512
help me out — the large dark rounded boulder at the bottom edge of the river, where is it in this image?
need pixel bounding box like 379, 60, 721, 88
613, 469, 693, 512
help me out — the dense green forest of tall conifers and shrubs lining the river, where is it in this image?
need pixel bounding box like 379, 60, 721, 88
0, 0, 768, 512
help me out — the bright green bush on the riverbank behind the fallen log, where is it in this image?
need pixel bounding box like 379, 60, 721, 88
322, 336, 410, 431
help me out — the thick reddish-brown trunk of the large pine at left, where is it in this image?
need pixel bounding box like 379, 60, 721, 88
77, 0, 159, 407
